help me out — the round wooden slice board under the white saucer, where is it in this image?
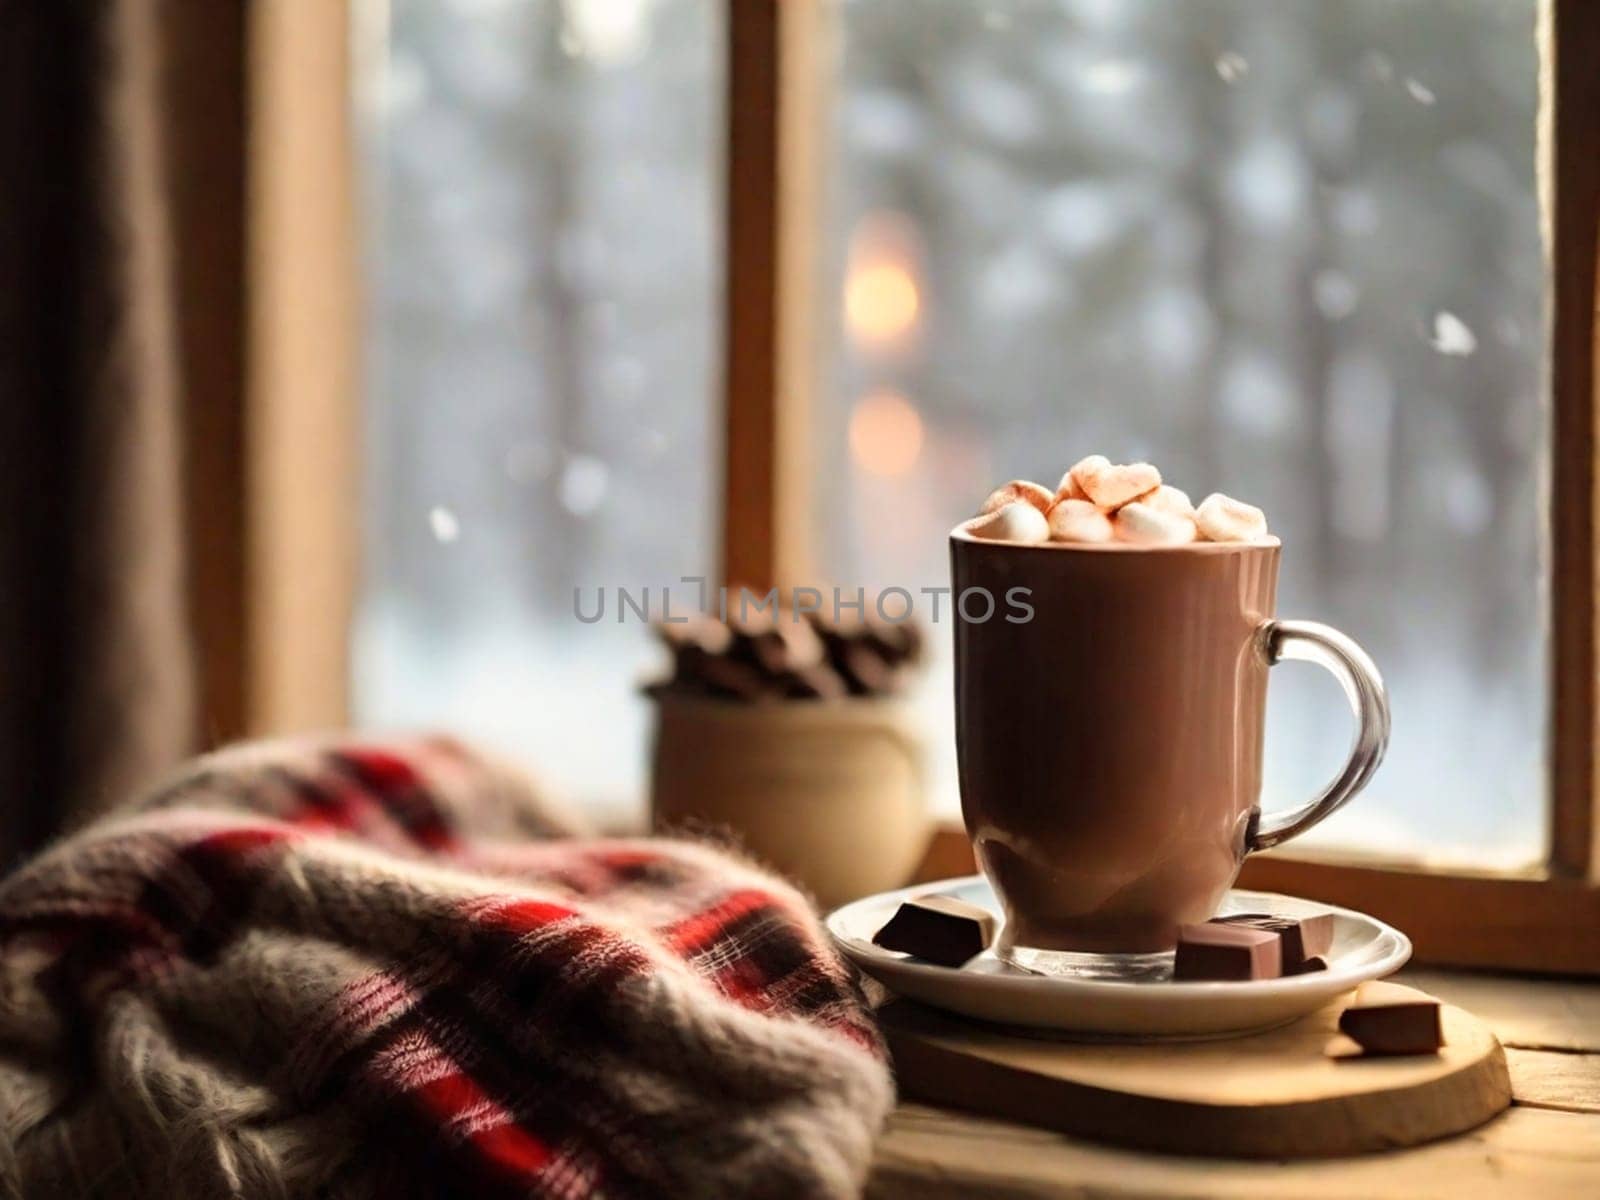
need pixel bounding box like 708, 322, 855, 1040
878, 984, 1510, 1158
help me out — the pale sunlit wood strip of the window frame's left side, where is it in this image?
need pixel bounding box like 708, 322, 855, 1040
242, 0, 362, 733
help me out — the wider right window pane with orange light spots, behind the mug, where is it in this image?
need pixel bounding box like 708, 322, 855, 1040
818, 0, 1549, 864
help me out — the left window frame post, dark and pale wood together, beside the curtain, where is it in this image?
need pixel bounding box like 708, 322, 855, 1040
183, 0, 362, 749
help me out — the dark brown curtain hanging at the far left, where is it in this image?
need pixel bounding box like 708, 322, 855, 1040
0, 0, 195, 864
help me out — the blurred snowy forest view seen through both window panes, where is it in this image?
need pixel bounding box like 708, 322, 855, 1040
355, 0, 1549, 866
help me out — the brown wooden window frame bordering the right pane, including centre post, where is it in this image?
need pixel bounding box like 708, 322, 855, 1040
723, 0, 1600, 973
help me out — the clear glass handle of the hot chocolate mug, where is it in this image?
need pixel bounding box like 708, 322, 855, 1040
1245, 621, 1389, 851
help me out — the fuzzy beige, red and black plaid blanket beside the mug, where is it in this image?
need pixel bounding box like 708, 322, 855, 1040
0, 739, 893, 1200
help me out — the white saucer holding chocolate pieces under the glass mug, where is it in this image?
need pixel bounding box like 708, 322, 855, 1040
827, 875, 1411, 1038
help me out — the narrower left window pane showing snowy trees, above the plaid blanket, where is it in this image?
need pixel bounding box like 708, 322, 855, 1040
355, 0, 722, 814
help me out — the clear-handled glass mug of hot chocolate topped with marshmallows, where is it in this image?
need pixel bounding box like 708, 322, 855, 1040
950, 459, 1387, 970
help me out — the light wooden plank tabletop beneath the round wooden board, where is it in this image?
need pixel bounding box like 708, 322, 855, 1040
867, 968, 1600, 1200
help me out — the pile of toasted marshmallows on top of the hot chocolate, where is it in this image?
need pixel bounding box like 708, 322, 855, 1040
963, 454, 1267, 546
